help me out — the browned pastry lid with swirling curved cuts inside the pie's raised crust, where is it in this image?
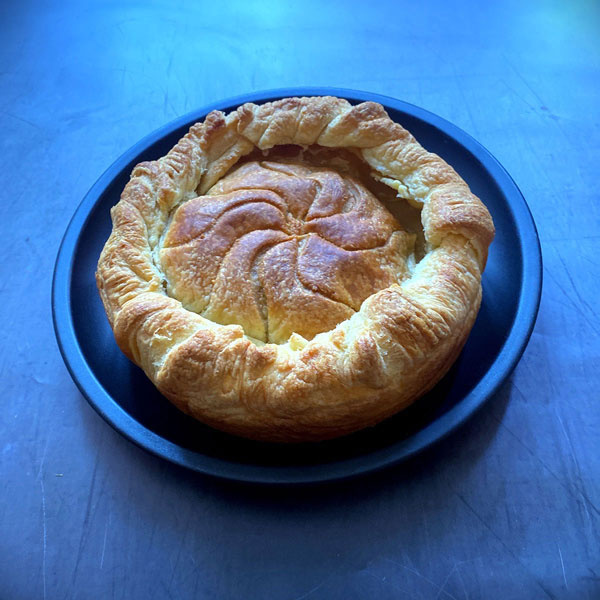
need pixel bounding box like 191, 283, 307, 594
160, 160, 414, 343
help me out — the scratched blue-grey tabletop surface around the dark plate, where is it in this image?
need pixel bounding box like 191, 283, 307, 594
0, 0, 600, 600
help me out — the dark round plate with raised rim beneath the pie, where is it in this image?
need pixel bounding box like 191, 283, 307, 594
52, 88, 541, 483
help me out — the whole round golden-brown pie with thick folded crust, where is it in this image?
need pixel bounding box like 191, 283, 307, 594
96, 97, 494, 442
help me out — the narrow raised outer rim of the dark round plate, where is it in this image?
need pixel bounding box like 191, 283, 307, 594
51, 87, 543, 484
